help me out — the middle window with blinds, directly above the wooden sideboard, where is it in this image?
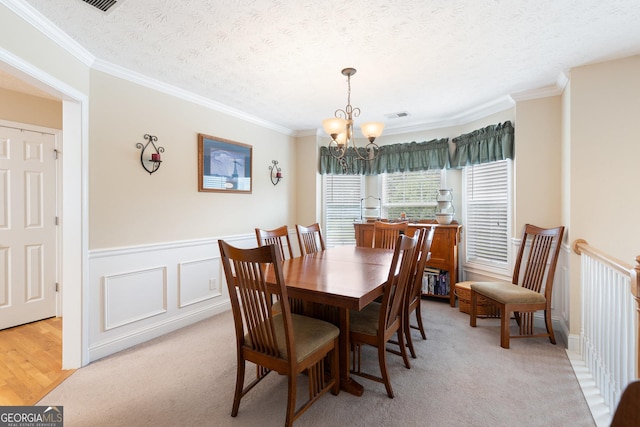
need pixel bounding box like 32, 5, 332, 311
382, 170, 442, 219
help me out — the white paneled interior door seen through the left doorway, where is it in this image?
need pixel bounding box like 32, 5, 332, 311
0, 126, 57, 329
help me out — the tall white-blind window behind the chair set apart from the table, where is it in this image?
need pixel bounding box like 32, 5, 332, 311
464, 160, 511, 268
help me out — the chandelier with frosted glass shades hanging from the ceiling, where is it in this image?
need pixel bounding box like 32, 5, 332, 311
322, 68, 384, 169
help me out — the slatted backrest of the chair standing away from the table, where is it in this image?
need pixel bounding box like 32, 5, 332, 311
511, 224, 564, 301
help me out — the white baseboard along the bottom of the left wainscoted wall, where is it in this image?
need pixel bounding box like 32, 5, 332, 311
89, 298, 231, 363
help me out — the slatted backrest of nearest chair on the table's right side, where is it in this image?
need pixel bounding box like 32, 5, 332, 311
379, 230, 421, 331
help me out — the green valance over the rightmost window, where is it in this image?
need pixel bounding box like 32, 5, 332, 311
451, 121, 514, 169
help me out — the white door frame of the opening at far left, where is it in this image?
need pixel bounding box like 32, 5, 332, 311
0, 47, 89, 369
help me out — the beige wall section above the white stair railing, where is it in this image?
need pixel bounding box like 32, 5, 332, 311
569, 56, 640, 263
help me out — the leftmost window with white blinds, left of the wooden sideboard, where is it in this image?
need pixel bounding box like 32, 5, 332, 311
322, 175, 364, 246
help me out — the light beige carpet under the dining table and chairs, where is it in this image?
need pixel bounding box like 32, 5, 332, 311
38, 300, 595, 427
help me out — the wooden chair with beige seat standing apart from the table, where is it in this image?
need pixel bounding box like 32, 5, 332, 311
469, 224, 564, 348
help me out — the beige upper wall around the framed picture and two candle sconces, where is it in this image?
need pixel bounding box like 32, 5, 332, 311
89, 71, 296, 249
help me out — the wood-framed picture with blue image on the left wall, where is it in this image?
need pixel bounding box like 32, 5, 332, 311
198, 133, 253, 194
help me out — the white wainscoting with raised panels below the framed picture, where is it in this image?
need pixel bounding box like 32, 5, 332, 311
89, 233, 256, 362
